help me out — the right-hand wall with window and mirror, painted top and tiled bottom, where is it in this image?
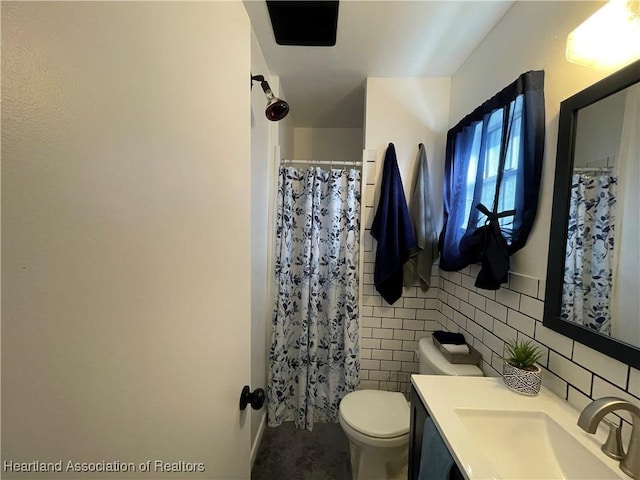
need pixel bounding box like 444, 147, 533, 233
440, 2, 640, 433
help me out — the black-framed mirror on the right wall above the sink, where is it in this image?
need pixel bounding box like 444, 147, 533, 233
543, 61, 640, 368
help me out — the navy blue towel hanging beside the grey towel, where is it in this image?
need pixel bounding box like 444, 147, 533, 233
371, 143, 417, 304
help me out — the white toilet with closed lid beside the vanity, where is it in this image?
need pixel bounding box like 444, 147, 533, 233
338, 336, 483, 480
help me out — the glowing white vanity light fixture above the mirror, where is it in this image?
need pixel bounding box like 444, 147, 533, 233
566, 0, 640, 68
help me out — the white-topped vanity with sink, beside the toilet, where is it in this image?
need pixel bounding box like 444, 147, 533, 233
409, 375, 629, 480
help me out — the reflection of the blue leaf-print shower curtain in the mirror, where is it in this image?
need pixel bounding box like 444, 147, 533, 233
561, 174, 617, 335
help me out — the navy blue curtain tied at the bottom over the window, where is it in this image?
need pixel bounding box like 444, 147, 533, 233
439, 71, 545, 290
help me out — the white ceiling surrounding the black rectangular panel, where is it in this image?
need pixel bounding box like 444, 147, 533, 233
244, 0, 513, 128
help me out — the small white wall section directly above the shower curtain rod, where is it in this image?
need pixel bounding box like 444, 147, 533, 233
293, 127, 364, 161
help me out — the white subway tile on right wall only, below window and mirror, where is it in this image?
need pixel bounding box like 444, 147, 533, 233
439, 265, 640, 408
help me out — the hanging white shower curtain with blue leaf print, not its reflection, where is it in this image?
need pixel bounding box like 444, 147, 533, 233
267, 166, 360, 430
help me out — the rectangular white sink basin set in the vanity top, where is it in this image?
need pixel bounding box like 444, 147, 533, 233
454, 408, 620, 479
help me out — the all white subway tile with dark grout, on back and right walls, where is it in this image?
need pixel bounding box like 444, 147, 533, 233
359, 156, 640, 420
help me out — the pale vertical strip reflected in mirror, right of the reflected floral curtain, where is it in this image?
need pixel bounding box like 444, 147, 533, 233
611, 84, 640, 346
